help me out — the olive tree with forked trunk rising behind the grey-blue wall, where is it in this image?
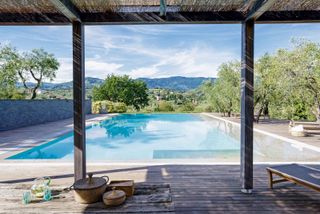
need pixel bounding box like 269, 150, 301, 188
0, 46, 59, 99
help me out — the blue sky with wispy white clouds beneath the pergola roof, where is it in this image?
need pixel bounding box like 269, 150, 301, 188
0, 24, 320, 82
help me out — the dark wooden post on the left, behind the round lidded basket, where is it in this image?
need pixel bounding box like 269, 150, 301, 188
72, 21, 86, 181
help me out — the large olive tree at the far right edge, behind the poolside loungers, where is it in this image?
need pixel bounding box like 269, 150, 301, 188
276, 40, 320, 120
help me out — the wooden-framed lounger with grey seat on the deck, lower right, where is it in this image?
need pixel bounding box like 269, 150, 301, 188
267, 164, 320, 192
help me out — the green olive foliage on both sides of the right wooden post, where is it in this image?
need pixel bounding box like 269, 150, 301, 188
202, 40, 320, 121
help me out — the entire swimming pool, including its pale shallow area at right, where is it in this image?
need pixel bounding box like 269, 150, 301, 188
8, 114, 320, 161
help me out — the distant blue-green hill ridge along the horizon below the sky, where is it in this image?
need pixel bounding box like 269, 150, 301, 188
17, 76, 215, 91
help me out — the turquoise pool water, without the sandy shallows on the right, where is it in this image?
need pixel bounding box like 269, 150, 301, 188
10, 114, 239, 160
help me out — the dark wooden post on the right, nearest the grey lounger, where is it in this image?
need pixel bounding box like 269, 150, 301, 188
241, 20, 254, 193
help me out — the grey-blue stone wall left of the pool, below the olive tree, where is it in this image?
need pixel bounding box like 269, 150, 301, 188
0, 100, 91, 131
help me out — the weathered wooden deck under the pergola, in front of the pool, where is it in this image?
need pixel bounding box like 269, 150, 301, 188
0, 164, 320, 213
